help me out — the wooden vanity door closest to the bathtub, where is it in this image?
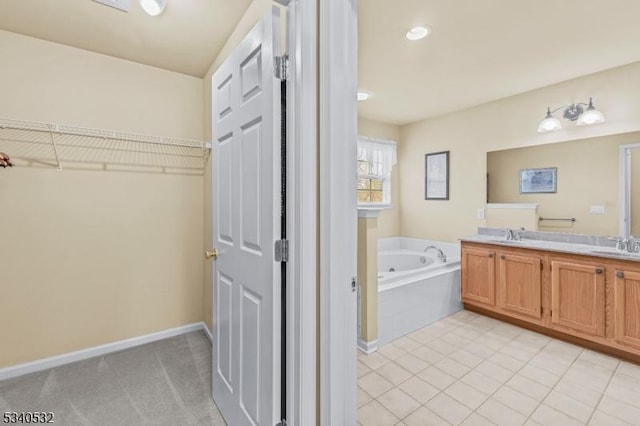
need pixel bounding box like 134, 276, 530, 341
462, 248, 496, 306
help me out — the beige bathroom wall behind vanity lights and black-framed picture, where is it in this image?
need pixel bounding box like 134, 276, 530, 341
399, 62, 640, 241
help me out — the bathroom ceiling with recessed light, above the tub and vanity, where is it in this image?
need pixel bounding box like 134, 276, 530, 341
359, 0, 640, 125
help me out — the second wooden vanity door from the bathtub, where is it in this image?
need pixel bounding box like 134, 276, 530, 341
498, 253, 542, 319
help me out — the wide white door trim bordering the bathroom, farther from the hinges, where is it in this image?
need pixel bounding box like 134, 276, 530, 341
319, 0, 358, 426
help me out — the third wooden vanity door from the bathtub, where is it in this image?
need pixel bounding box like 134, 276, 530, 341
551, 261, 605, 336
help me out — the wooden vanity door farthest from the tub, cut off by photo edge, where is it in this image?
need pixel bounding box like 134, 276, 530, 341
615, 271, 640, 349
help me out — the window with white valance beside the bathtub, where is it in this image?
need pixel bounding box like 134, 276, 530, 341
357, 137, 397, 204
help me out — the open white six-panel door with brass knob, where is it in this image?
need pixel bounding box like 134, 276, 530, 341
211, 8, 280, 426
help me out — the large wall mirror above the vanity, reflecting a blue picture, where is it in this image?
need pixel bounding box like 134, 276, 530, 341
487, 132, 640, 236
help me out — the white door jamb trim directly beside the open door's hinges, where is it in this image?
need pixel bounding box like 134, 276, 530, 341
287, 0, 318, 426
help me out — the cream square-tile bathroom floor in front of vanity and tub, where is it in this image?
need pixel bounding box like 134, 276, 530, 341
358, 311, 640, 426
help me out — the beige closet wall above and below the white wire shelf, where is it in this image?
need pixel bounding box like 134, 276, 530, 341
0, 31, 203, 368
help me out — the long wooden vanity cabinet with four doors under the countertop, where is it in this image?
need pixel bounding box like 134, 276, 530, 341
461, 241, 640, 363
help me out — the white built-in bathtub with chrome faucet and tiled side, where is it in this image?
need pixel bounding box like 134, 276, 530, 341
377, 238, 462, 346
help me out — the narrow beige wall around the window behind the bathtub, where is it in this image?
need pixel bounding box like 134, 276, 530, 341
358, 117, 400, 238
